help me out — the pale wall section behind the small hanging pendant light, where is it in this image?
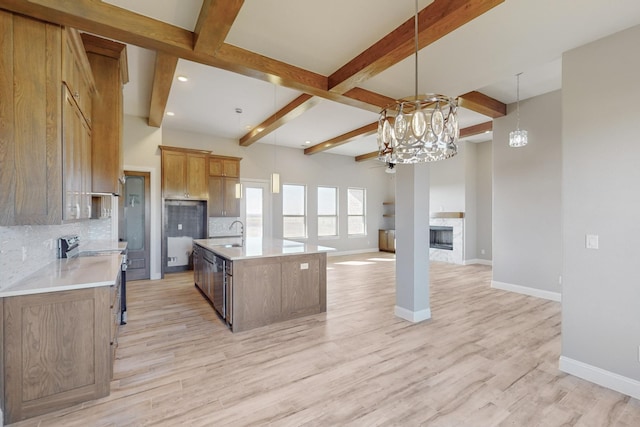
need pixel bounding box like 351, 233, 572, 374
492, 91, 562, 300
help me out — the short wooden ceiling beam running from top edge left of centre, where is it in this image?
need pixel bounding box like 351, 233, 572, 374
193, 0, 244, 55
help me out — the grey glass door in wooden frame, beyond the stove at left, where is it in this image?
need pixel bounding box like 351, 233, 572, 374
120, 171, 151, 280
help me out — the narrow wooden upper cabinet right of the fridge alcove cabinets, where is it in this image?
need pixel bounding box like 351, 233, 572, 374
209, 156, 241, 217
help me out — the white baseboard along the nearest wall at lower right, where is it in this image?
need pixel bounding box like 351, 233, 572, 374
559, 356, 640, 399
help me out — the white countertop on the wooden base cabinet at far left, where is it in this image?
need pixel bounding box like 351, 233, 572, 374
0, 254, 122, 298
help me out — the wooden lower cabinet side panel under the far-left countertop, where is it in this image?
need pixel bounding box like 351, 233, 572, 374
0, 281, 120, 423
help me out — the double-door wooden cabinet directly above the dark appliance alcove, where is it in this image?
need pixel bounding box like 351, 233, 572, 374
159, 145, 209, 200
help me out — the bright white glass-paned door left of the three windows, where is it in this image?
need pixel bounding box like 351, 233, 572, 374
240, 180, 271, 238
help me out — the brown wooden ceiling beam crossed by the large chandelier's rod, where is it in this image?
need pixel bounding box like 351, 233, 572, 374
329, 0, 504, 93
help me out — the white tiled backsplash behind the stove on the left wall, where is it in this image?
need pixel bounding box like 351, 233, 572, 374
0, 219, 111, 289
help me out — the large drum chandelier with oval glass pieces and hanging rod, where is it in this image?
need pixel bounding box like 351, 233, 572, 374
378, 0, 460, 164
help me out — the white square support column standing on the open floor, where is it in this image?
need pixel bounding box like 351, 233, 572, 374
395, 163, 431, 322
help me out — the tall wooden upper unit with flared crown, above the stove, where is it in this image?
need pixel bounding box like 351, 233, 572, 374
82, 33, 129, 194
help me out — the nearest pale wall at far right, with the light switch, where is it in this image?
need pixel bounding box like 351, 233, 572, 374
561, 22, 640, 392
